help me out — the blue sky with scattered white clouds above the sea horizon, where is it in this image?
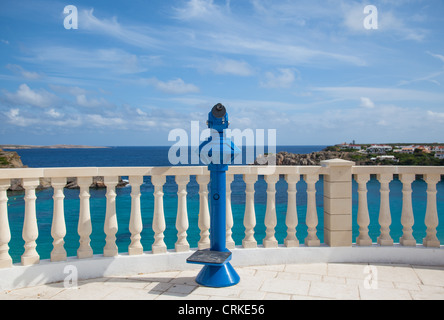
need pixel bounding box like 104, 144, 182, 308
0, 0, 444, 146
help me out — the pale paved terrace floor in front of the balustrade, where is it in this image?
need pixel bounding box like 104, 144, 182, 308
0, 263, 444, 300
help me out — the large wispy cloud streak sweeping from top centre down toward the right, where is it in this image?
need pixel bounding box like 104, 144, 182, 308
170, 0, 366, 66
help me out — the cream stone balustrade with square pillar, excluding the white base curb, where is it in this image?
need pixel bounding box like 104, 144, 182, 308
0, 160, 444, 269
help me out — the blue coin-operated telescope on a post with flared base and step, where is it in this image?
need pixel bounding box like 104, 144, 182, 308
187, 103, 241, 288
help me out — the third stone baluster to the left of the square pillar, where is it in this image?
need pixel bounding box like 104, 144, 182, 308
263, 174, 279, 248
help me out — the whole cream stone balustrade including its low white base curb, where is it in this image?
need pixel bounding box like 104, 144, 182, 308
0, 164, 444, 290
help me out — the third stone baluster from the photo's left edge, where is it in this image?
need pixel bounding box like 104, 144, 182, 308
51, 178, 67, 262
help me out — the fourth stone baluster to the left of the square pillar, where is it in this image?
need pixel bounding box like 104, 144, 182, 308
242, 174, 257, 248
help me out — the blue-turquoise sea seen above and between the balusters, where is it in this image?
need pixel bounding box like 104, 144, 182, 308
4, 146, 444, 262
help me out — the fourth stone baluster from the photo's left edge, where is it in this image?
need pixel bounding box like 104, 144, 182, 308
77, 177, 93, 259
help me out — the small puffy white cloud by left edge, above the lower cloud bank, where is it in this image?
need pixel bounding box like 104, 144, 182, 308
5, 84, 58, 108
